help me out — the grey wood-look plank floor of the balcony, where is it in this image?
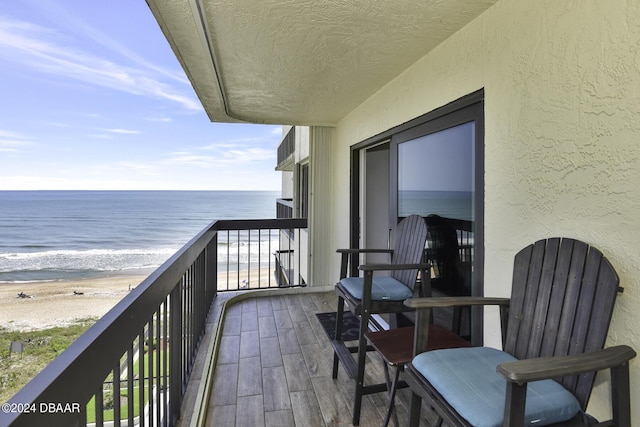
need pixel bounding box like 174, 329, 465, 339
206, 292, 438, 427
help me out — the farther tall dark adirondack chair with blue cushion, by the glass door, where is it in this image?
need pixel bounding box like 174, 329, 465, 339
331, 215, 429, 425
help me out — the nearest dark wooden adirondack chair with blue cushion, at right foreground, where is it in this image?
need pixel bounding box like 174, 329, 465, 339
406, 238, 635, 426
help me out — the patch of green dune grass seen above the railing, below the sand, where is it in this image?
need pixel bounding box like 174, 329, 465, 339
0, 319, 96, 402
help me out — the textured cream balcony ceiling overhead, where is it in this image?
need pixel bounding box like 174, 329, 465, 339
147, 0, 497, 125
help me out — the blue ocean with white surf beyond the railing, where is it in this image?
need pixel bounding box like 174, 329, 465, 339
0, 191, 280, 283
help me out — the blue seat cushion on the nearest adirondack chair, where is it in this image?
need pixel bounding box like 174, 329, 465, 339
412, 347, 580, 427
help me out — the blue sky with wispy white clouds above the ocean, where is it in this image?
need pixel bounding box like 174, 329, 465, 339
0, 0, 281, 190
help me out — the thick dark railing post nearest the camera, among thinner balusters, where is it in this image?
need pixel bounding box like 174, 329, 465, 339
169, 282, 181, 426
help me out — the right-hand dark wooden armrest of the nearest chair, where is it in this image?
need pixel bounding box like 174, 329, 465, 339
496, 345, 636, 384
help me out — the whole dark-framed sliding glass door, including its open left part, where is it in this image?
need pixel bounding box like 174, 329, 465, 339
350, 90, 484, 345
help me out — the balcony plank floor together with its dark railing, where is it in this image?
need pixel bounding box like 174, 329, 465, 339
0, 219, 442, 427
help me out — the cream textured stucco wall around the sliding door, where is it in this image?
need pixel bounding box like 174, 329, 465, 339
331, 0, 640, 425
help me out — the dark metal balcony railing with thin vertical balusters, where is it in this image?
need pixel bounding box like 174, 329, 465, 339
0, 219, 307, 427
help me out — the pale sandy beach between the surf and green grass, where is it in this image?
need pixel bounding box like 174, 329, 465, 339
0, 276, 146, 330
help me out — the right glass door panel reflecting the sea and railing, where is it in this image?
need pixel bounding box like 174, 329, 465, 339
390, 98, 484, 343
